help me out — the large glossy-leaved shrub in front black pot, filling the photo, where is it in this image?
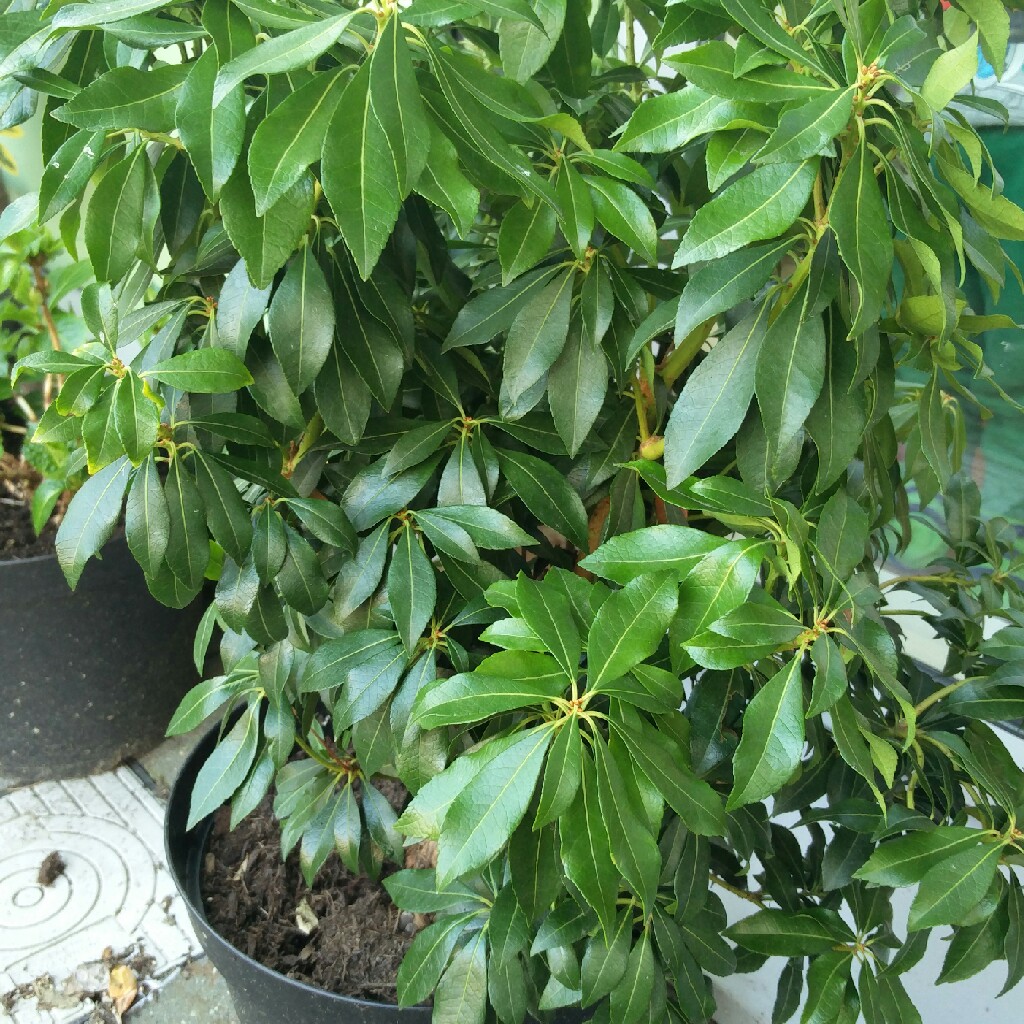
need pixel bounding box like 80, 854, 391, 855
8, 0, 1024, 1024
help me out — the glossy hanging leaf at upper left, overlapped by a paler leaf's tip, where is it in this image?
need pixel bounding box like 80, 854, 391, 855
174, 46, 246, 203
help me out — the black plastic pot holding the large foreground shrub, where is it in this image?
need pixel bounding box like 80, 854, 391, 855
164, 729, 585, 1024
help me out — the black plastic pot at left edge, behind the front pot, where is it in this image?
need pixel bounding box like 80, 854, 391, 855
0, 539, 203, 790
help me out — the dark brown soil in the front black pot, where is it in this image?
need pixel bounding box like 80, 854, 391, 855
202, 794, 417, 1004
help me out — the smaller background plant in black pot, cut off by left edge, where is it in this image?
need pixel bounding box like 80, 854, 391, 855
0, 207, 200, 788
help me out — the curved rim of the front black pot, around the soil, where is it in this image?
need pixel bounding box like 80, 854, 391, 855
164, 722, 433, 1021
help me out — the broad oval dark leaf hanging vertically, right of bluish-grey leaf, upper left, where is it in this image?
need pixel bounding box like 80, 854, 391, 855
266, 245, 334, 394
